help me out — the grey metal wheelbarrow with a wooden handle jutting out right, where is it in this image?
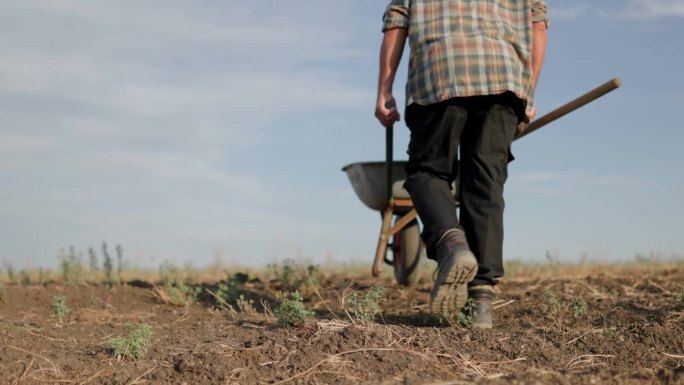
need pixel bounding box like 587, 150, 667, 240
342, 78, 622, 286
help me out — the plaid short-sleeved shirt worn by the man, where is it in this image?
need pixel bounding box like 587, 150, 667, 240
383, 0, 548, 105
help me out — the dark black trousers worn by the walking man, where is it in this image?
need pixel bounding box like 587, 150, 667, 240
405, 92, 524, 284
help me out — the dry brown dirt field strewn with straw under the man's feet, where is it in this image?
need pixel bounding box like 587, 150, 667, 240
0, 263, 684, 384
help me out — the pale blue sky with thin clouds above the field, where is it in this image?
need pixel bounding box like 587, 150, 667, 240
0, 0, 684, 267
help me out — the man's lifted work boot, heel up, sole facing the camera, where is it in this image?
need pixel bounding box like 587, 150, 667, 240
430, 229, 478, 315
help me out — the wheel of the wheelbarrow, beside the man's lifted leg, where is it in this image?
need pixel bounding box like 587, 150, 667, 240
392, 218, 421, 286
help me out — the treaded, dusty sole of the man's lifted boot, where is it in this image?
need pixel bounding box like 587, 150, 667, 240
430, 254, 478, 315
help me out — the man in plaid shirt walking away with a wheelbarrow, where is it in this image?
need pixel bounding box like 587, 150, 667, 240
375, 0, 548, 328
